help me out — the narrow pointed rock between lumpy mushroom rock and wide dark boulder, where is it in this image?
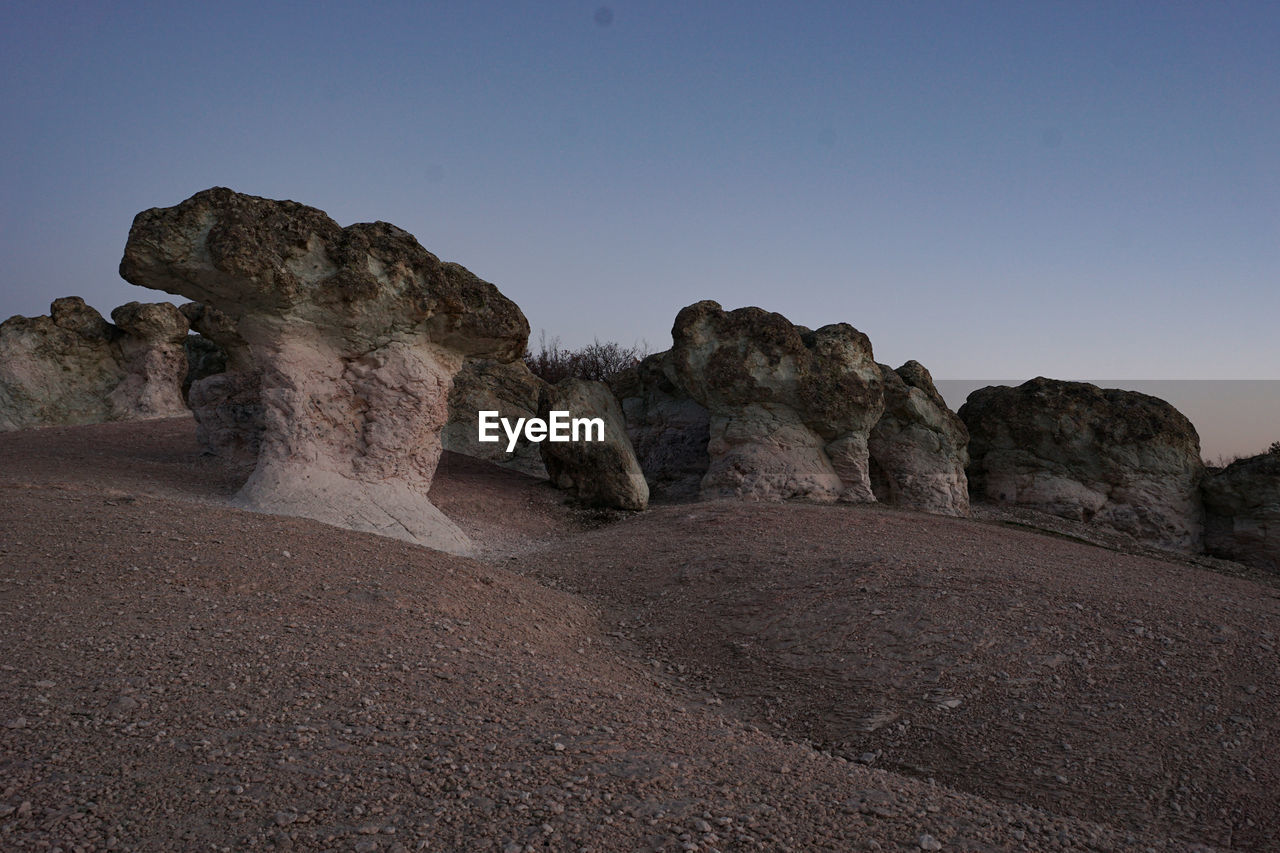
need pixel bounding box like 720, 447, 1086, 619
868, 361, 969, 515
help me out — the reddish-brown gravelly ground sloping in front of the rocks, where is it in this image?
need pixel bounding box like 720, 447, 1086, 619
0, 419, 1280, 853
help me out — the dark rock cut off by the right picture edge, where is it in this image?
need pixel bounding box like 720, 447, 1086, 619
1202, 453, 1280, 571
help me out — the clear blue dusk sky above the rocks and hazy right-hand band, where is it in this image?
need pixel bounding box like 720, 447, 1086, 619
0, 0, 1280, 379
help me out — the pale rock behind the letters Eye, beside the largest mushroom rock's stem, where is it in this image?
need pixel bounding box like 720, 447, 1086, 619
442, 359, 547, 478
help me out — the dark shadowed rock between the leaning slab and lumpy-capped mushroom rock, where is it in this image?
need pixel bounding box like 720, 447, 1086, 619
609, 353, 710, 501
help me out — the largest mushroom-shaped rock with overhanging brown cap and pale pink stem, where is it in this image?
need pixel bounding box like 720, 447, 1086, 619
120, 188, 529, 552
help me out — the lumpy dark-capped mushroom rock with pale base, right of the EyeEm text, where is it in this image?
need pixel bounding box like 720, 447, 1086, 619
666, 301, 884, 502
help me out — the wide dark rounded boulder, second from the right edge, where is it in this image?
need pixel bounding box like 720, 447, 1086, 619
959, 378, 1203, 551
